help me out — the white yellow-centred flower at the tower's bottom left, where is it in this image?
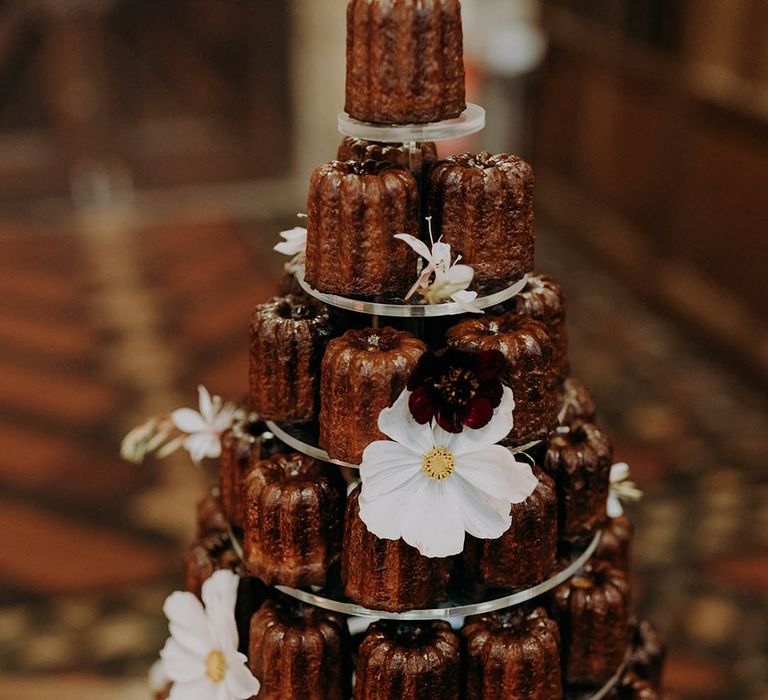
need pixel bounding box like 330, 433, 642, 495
160, 570, 260, 700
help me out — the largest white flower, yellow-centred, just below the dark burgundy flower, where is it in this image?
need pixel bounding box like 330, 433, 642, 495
360, 387, 538, 557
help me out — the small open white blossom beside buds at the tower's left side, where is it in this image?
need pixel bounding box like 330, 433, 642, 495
171, 385, 242, 462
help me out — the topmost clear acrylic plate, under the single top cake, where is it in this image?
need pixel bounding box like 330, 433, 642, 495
338, 103, 485, 143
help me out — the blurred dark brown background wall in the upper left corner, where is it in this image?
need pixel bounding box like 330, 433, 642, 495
0, 0, 291, 201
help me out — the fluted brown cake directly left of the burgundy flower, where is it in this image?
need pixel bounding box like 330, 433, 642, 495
320, 328, 427, 464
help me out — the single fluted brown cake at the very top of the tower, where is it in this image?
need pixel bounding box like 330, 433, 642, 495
344, 0, 466, 124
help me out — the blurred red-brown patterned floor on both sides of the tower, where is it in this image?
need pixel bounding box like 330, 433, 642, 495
0, 211, 768, 700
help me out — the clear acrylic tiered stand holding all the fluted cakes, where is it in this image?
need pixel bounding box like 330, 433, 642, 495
252, 104, 625, 700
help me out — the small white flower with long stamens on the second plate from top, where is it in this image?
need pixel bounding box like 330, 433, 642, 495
395, 226, 483, 314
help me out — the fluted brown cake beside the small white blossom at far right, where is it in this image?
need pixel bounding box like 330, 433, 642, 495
544, 420, 613, 541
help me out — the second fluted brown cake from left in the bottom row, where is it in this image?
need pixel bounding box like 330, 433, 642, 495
354, 620, 461, 700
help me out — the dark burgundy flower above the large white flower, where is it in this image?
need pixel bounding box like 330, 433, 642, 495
408, 348, 506, 433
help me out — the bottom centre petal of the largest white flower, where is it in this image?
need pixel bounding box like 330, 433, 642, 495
401, 477, 464, 557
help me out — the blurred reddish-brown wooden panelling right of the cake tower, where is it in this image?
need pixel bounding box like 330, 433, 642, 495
535, 0, 768, 380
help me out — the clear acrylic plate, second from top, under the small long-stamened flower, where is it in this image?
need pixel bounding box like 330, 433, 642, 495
296, 267, 528, 318
